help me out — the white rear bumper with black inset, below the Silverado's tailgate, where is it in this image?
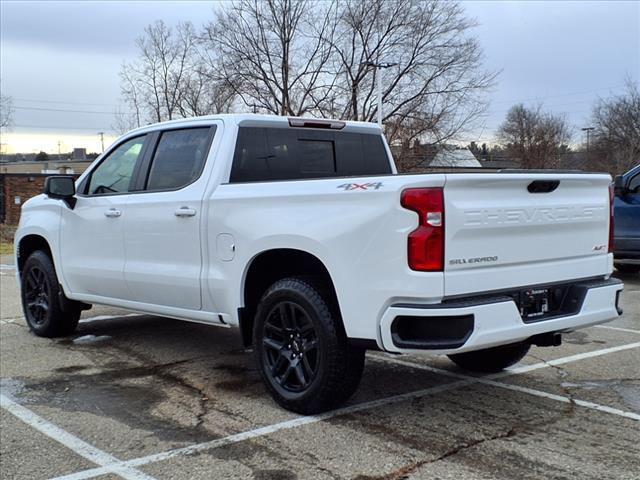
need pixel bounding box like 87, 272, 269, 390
380, 279, 623, 354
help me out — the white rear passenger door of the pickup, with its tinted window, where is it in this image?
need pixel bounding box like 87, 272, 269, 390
124, 125, 216, 310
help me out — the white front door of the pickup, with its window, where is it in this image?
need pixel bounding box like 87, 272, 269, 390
60, 135, 146, 299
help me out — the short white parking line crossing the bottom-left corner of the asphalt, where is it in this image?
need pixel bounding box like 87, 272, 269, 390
0, 393, 155, 480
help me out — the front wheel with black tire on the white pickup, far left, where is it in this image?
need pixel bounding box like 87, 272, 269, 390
20, 250, 81, 337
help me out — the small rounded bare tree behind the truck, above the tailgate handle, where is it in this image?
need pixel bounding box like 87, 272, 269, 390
497, 104, 571, 168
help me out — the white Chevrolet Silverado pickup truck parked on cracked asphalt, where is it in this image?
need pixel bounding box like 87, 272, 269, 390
15, 115, 622, 413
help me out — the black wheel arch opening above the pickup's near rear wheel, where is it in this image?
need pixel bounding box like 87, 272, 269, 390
238, 248, 344, 346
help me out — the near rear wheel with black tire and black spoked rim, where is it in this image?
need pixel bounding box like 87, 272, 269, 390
253, 278, 365, 415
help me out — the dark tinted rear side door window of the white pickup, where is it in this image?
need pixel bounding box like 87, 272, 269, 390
146, 127, 211, 190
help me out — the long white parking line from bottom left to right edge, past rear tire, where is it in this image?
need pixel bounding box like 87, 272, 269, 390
45, 342, 640, 480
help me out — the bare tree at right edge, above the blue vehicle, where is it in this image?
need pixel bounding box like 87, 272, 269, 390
590, 78, 640, 173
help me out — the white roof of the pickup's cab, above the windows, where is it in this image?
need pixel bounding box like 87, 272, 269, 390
127, 113, 382, 135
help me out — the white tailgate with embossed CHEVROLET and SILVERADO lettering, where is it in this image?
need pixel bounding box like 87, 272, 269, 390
444, 173, 612, 296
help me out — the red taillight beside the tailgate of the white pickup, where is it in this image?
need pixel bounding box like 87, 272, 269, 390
400, 188, 444, 272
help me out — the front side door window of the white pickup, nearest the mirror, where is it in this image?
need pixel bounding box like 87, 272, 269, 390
86, 135, 145, 195
